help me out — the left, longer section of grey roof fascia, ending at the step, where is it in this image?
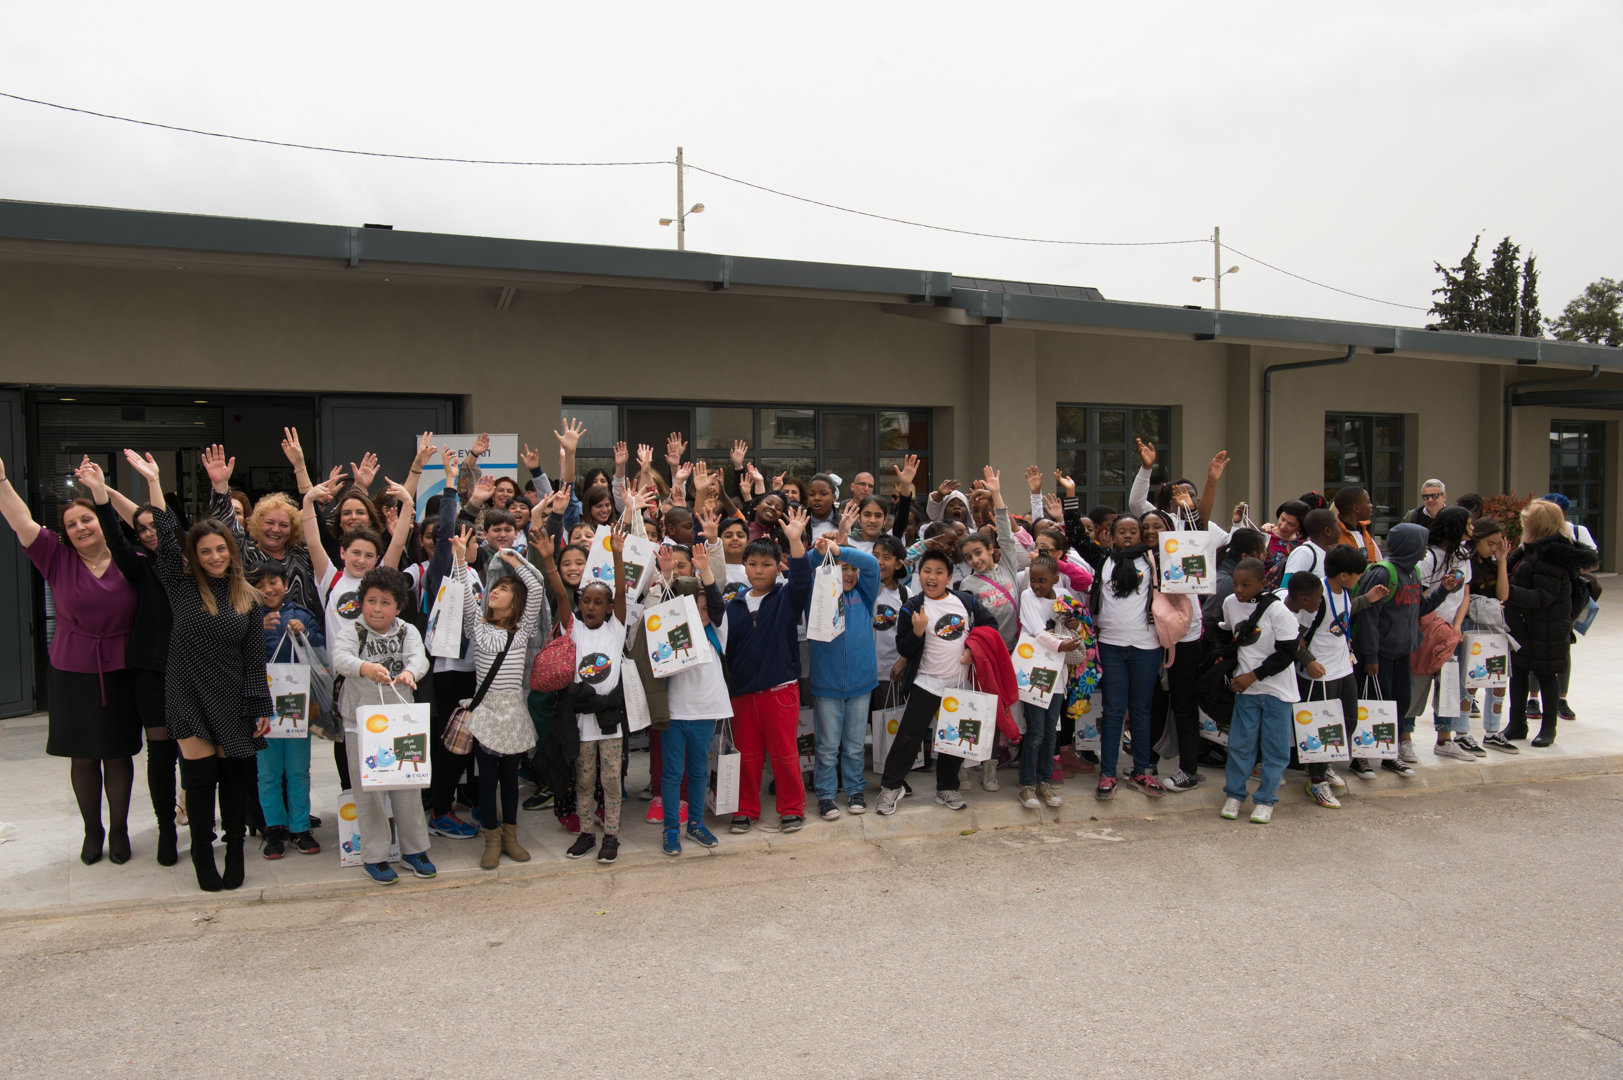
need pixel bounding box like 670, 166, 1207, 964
0, 200, 953, 302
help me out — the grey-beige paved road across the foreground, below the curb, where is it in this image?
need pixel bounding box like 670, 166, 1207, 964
0, 776, 1623, 1080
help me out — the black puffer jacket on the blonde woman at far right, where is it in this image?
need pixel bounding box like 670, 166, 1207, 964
1505, 536, 1599, 672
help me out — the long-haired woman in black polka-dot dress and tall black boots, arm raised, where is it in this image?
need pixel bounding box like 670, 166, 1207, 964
121, 450, 273, 892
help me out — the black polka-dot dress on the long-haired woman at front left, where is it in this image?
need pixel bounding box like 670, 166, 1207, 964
153, 510, 271, 757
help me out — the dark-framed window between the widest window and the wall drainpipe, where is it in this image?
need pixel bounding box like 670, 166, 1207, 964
1045, 404, 1172, 513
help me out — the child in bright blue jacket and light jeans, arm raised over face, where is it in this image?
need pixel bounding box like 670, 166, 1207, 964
807, 533, 880, 822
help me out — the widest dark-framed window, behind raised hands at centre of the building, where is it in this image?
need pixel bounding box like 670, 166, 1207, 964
563, 400, 932, 495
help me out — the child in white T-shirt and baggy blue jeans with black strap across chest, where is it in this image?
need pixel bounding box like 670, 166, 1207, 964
1220, 559, 1304, 825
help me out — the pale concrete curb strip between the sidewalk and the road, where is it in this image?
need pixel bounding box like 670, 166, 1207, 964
0, 750, 1623, 926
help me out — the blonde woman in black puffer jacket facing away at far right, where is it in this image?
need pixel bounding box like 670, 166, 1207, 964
1505, 499, 1599, 747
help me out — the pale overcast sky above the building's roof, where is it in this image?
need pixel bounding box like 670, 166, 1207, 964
0, 0, 1623, 325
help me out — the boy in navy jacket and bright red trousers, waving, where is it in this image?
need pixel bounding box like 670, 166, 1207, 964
722, 510, 812, 833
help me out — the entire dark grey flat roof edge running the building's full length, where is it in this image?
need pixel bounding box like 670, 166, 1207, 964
0, 200, 1623, 370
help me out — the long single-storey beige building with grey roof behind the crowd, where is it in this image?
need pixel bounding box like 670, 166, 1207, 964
0, 201, 1623, 715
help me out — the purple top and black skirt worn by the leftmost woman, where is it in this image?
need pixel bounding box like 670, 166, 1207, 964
28, 528, 141, 757
